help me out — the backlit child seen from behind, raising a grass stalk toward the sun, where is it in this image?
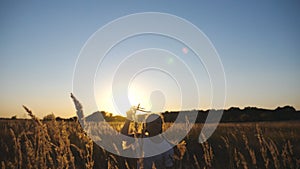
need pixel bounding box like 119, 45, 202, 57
121, 109, 174, 169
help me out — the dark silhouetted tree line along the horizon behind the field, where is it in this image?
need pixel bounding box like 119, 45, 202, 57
4, 106, 300, 123
